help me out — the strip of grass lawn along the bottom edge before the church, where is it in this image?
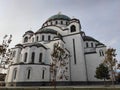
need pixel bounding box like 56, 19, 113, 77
0, 86, 120, 90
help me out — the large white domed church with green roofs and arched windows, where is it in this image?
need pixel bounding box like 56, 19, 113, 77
5, 13, 106, 86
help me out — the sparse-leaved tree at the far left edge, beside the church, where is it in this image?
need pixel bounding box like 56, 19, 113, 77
0, 35, 12, 85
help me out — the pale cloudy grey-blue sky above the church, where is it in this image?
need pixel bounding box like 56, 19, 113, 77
0, 0, 120, 61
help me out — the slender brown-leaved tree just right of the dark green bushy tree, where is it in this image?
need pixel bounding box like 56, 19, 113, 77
104, 48, 117, 85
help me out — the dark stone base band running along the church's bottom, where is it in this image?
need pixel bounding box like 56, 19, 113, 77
3, 81, 111, 87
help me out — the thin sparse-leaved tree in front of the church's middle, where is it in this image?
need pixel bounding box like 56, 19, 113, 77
50, 43, 69, 89
